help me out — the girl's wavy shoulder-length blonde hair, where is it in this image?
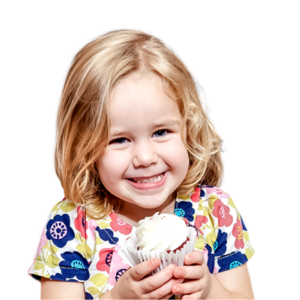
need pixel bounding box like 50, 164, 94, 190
55, 30, 223, 219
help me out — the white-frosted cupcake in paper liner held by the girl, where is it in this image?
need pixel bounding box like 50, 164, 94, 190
119, 212, 197, 274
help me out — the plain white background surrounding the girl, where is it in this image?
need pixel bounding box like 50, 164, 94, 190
0, 0, 300, 299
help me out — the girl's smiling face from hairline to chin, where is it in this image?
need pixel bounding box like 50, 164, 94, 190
97, 73, 189, 209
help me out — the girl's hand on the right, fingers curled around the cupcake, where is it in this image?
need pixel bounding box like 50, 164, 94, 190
172, 251, 212, 300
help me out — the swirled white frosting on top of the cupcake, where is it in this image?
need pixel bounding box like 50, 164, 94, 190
136, 212, 188, 252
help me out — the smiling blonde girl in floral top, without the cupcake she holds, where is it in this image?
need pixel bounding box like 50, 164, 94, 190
29, 30, 254, 299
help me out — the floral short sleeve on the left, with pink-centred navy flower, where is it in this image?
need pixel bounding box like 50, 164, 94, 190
29, 199, 95, 282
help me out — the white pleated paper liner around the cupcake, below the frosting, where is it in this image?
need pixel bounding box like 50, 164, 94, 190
118, 227, 197, 275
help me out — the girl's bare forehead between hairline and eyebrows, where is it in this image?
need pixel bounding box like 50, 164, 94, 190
109, 74, 182, 129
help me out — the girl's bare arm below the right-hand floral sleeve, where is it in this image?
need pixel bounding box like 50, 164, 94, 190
209, 263, 254, 299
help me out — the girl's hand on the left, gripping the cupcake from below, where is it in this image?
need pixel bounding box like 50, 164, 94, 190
110, 258, 183, 299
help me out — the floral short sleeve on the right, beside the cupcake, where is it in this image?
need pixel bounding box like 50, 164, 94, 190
197, 186, 254, 273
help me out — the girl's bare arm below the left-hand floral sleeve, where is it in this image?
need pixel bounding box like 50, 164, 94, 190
41, 277, 85, 299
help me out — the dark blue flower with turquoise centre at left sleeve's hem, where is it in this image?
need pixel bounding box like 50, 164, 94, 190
50, 252, 90, 281
